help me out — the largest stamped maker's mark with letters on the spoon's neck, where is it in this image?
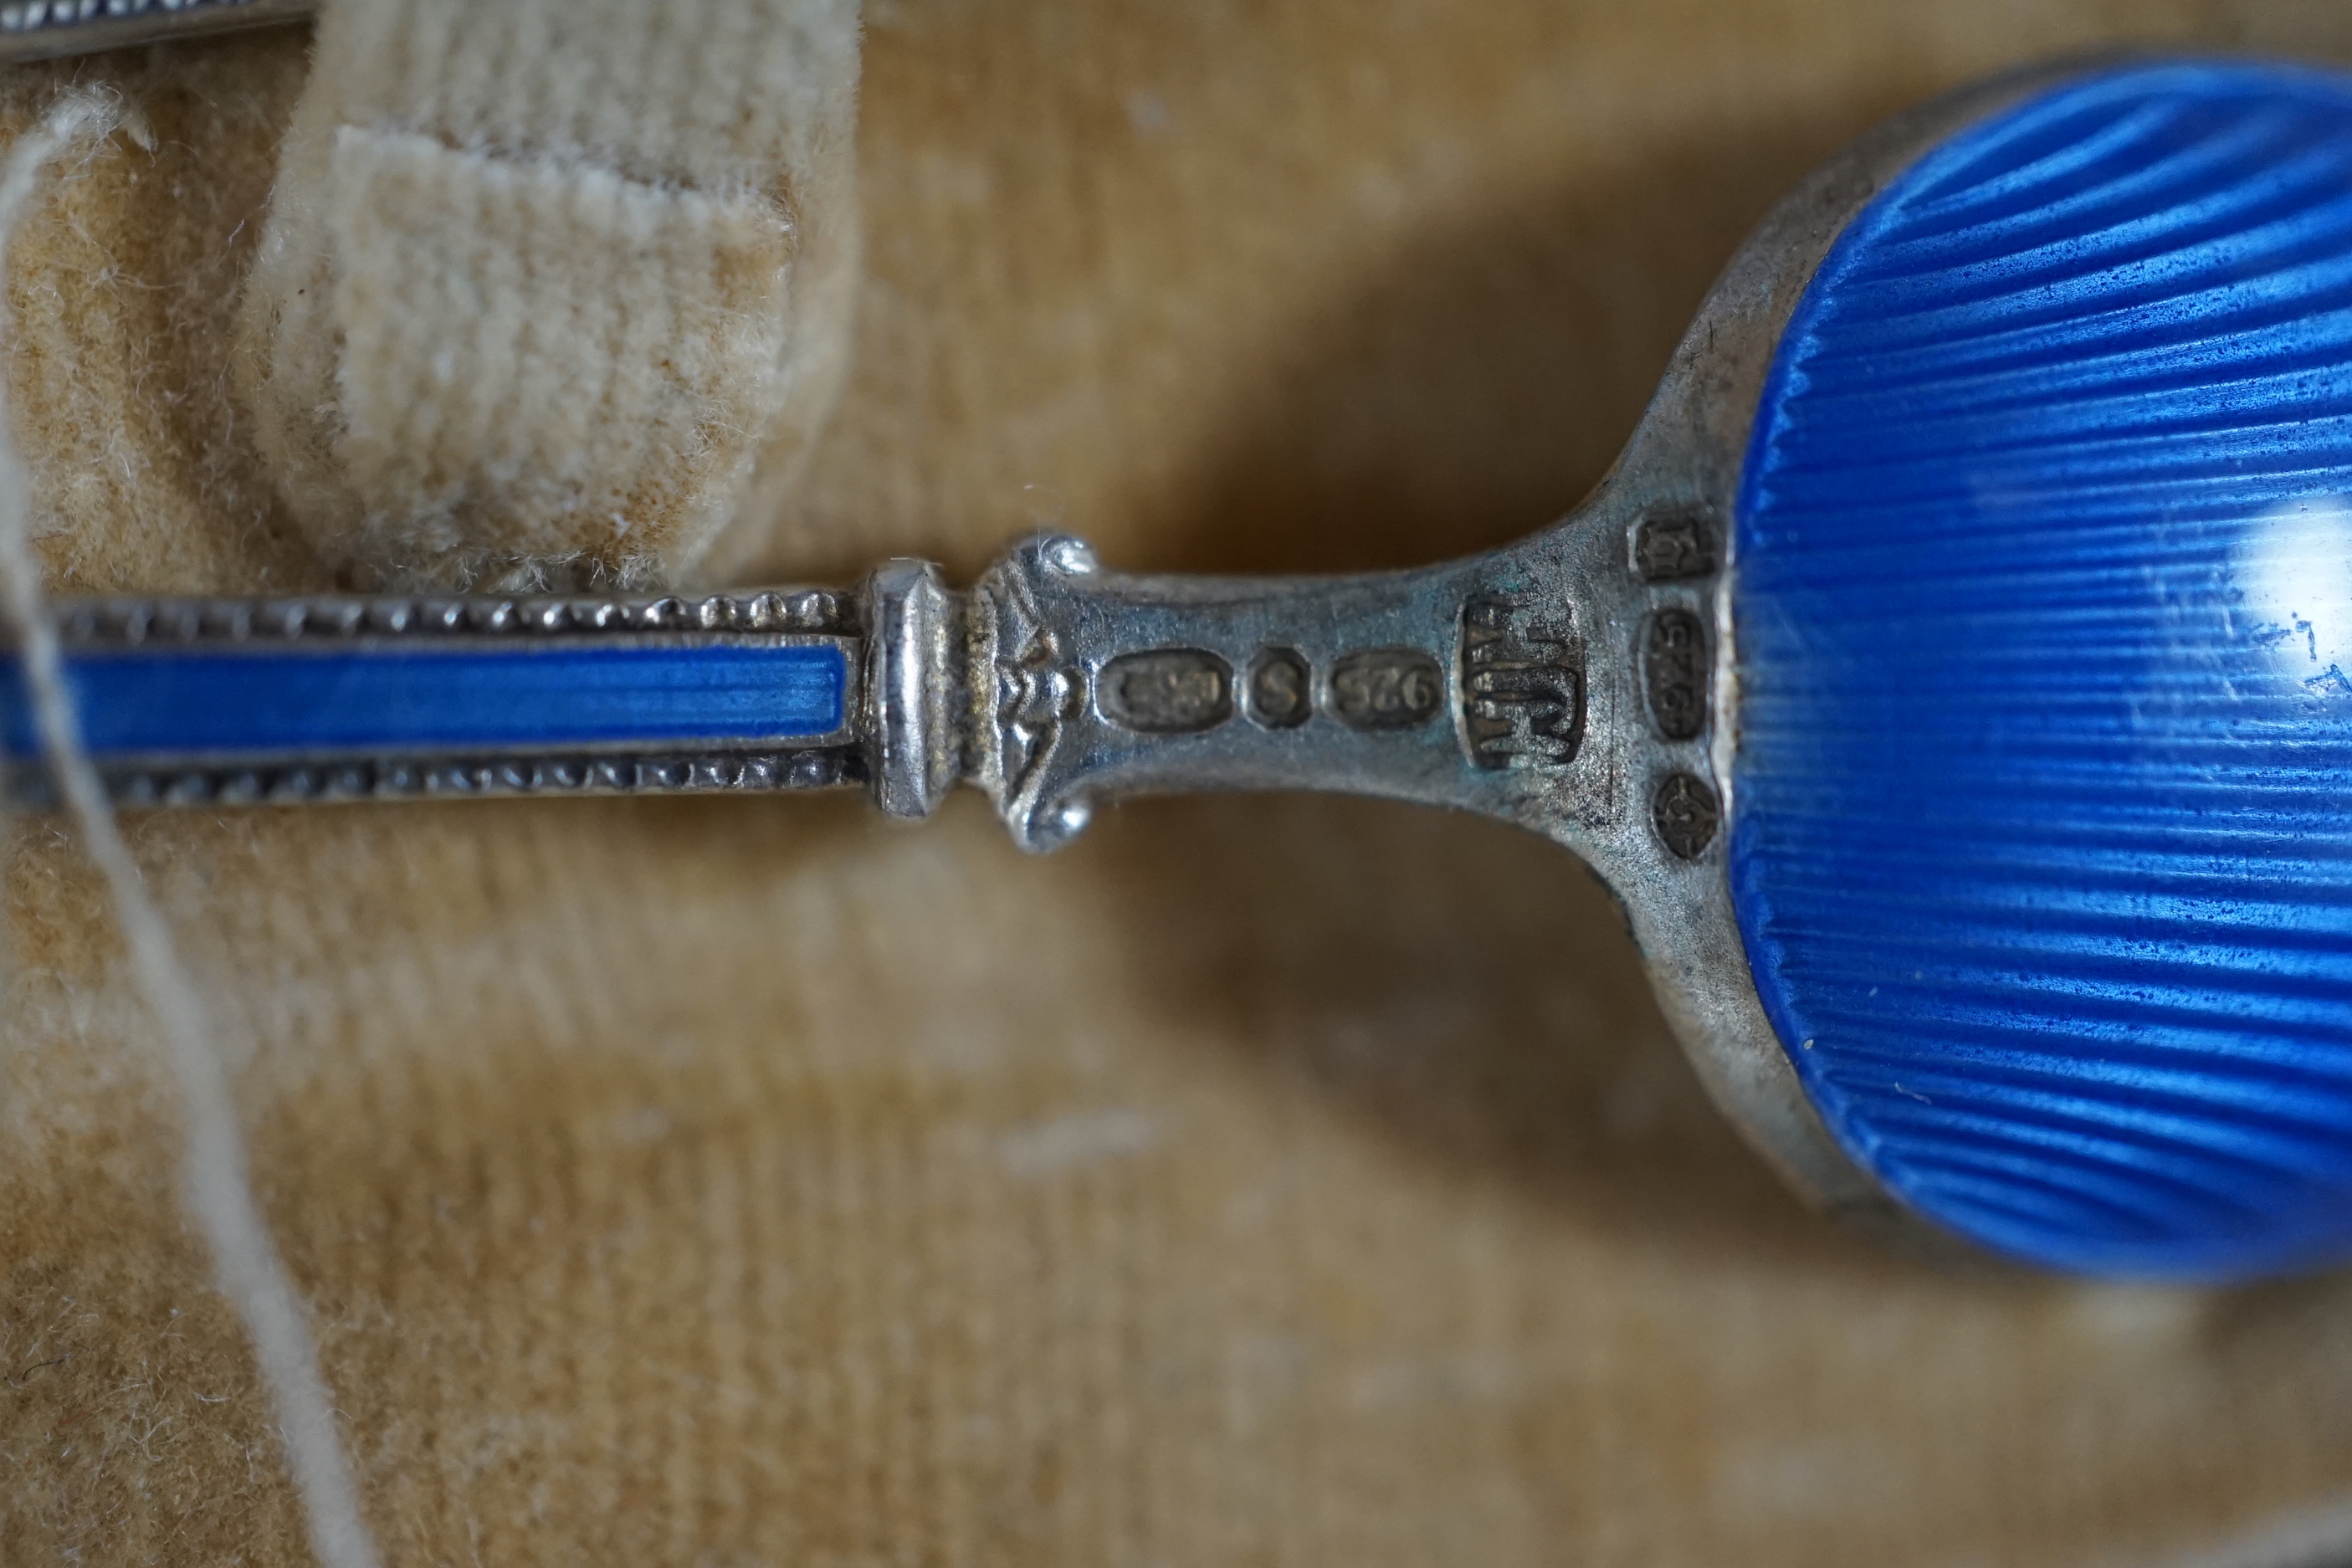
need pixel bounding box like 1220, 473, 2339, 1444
1463, 592, 1586, 769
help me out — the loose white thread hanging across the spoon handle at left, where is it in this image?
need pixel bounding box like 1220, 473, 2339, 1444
0, 94, 377, 1568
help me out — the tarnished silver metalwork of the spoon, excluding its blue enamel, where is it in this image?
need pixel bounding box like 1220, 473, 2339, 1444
0, 58, 2126, 1241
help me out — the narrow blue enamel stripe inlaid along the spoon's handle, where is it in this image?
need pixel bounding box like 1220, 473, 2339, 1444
0, 642, 849, 759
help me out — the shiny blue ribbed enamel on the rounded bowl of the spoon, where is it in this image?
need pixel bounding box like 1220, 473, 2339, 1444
1731, 64, 2352, 1278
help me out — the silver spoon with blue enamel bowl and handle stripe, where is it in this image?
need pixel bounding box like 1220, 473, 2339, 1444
0, 46, 2352, 1278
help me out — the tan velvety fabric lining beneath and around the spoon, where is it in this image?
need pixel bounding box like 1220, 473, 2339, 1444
0, 0, 2352, 1568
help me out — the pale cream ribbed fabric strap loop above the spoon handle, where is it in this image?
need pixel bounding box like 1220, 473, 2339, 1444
235, 0, 858, 590
